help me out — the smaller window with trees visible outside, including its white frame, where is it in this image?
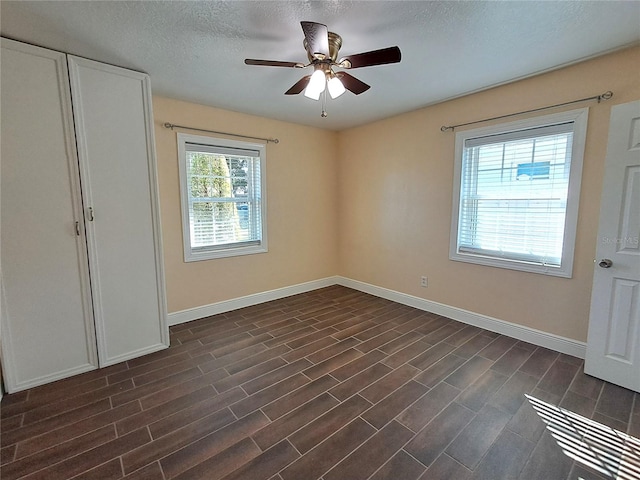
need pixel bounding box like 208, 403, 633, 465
178, 133, 267, 262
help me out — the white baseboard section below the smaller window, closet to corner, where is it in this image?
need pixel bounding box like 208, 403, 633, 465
169, 277, 339, 326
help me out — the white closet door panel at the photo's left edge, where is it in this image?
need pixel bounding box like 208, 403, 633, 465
0, 39, 97, 392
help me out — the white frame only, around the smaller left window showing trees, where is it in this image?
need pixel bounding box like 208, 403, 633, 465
177, 133, 268, 262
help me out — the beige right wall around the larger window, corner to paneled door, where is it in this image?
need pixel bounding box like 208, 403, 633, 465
338, 48, 640, 341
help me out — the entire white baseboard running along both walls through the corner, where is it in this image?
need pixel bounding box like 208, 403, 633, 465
168, 276, 586, 358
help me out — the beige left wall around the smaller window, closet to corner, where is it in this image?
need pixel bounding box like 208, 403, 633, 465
153, 97, 338, 313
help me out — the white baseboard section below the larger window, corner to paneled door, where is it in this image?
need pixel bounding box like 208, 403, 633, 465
337, 277, 586, 358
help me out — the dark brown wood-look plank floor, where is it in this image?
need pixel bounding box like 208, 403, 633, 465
0, 286, 640, 480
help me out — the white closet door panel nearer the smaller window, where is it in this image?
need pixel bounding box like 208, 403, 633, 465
68, 56, 169, 366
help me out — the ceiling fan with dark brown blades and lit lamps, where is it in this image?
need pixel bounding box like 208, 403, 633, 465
244, 22, 401, 112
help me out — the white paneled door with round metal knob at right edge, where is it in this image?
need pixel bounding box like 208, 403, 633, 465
585, 101, 640, 391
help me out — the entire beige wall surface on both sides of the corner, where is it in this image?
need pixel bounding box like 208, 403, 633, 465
153, 48, 640, 341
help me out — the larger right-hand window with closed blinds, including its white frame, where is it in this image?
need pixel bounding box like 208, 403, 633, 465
449, 109, 588, 277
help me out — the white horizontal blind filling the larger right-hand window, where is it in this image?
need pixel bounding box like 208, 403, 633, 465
458, 122, 574, 267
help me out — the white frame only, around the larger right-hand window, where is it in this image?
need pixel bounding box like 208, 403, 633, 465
449, 108, 589, 278
